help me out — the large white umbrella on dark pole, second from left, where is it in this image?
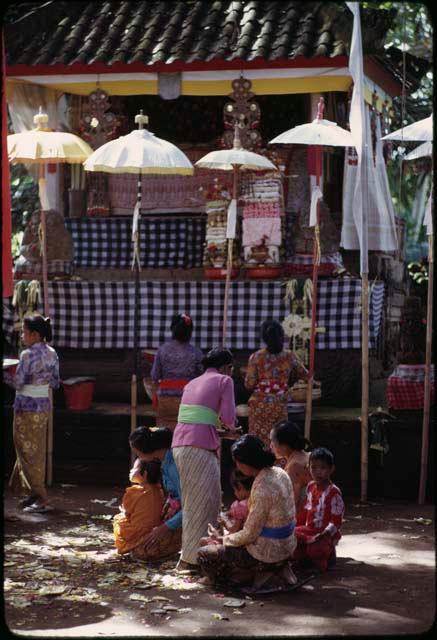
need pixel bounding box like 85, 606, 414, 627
84, 110, 194, 440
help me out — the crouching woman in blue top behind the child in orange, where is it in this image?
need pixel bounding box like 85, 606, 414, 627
129, 427, 182, 561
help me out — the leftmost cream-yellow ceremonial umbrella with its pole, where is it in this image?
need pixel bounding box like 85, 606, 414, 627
8, 107, 93, 486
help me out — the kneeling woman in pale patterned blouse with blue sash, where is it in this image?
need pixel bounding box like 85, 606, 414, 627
198, 434, 296, 583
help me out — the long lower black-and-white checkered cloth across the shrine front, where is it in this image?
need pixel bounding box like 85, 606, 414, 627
40, 280, 383, 349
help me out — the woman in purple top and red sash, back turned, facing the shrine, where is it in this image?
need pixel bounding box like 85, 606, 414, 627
151, 313, 203, 429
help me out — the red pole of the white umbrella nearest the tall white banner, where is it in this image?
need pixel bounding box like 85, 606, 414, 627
304, 145, 322, 440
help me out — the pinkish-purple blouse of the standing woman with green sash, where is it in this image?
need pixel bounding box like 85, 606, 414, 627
172, 367, 236, 451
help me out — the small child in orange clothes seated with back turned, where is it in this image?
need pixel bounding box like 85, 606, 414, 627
113, 460, 164, 554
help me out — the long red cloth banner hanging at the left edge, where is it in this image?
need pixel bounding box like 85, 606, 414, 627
1, 30, 14, 298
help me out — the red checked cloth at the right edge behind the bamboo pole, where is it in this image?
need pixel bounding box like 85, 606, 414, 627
387, 364, 434, 409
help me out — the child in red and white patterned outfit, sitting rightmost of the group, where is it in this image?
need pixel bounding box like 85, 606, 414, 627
293, 447, 344, 571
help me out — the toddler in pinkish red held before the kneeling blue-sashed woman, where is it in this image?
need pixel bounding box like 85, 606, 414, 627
200, 469, 254, 546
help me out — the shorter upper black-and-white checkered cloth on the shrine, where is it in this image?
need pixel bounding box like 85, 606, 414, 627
66, 216, 206, 269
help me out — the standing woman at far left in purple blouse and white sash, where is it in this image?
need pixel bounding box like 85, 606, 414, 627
5, 313, 59, 513
